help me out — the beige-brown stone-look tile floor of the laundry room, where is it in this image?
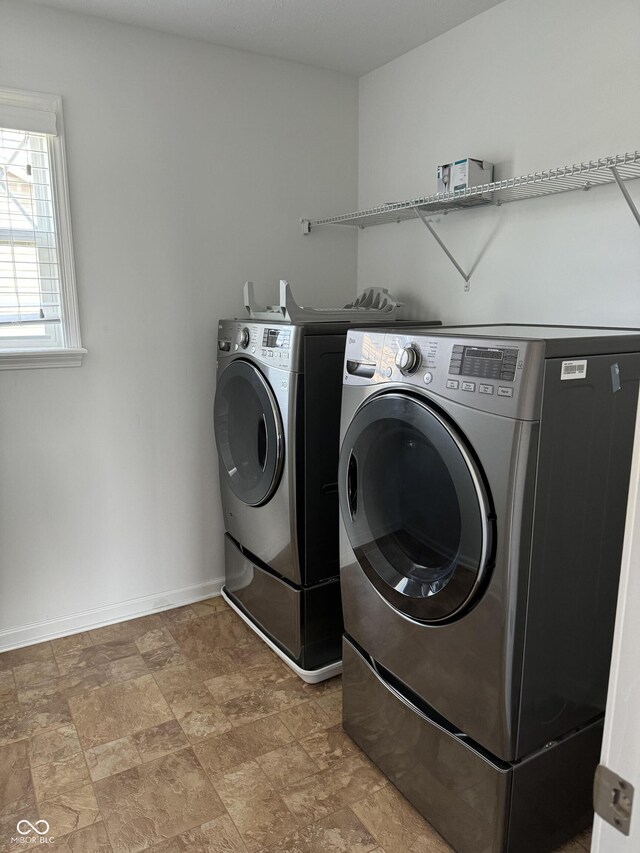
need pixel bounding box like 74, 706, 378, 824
0, 598, 590, 853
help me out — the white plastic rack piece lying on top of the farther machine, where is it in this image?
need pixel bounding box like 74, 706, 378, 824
244, 279, 404, 323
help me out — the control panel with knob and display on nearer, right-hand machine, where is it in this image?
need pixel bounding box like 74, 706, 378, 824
343, 329, 544, 419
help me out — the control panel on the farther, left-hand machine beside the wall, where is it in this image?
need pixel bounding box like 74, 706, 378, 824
218, 319, 299, 370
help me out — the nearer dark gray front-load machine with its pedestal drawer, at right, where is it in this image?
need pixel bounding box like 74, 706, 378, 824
338, 325, 640, 853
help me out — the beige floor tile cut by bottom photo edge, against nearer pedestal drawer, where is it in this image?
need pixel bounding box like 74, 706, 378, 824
351, 785, 451, 853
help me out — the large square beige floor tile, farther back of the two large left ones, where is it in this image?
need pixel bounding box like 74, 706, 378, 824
69, 675, 173, 749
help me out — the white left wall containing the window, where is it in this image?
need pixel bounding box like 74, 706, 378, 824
0, 0, 357, 648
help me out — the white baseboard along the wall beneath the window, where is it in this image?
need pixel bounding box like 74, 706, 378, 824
0, 577, 224, 653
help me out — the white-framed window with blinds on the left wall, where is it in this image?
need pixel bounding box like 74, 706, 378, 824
0, 89, 86, 369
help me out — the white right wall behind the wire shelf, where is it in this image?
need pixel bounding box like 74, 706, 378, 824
358, 0, 640, 326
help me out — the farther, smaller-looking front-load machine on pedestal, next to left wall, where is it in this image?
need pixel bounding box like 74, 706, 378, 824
214, 316, 440, 682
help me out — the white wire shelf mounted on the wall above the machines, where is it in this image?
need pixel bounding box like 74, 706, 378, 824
303, 151, 640, 232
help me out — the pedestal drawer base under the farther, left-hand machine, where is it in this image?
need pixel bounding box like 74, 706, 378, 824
225, 534, 343, 670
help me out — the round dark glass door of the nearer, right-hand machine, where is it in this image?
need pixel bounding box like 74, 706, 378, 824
338, 392, 494, 623
